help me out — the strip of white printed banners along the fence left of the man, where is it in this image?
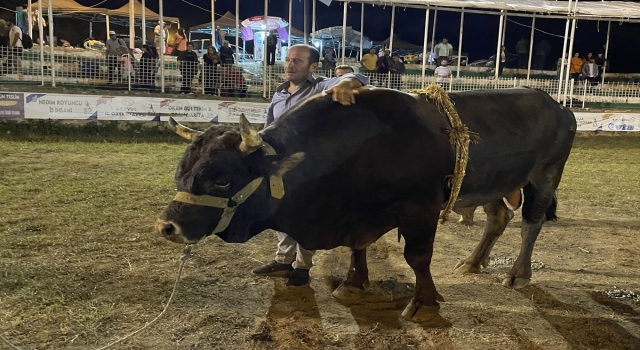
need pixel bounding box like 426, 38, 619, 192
14, 92, 269, 124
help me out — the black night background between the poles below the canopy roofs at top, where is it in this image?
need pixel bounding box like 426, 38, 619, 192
0, 0, 640, 73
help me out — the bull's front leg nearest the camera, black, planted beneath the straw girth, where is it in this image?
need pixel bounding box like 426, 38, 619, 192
399, 206, 450, 326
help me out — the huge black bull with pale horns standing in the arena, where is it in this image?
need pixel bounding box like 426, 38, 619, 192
156, 88, 576, 322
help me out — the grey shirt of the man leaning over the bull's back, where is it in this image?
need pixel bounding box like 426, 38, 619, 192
264, 73, 369, 127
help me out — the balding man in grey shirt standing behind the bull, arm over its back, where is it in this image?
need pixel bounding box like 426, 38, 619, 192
252, 44, 368, 286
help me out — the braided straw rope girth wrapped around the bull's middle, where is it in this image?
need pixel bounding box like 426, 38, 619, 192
409, 83, 480, 224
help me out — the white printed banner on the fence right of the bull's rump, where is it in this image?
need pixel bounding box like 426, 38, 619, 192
573, 112, 640, 131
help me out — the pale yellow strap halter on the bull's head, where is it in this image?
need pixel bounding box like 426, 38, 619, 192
173, 141, 284, 234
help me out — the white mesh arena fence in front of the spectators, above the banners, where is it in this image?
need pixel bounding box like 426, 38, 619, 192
0, 46, 640, 107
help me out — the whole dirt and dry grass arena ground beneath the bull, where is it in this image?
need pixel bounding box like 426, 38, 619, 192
0, 138, 640, 350
